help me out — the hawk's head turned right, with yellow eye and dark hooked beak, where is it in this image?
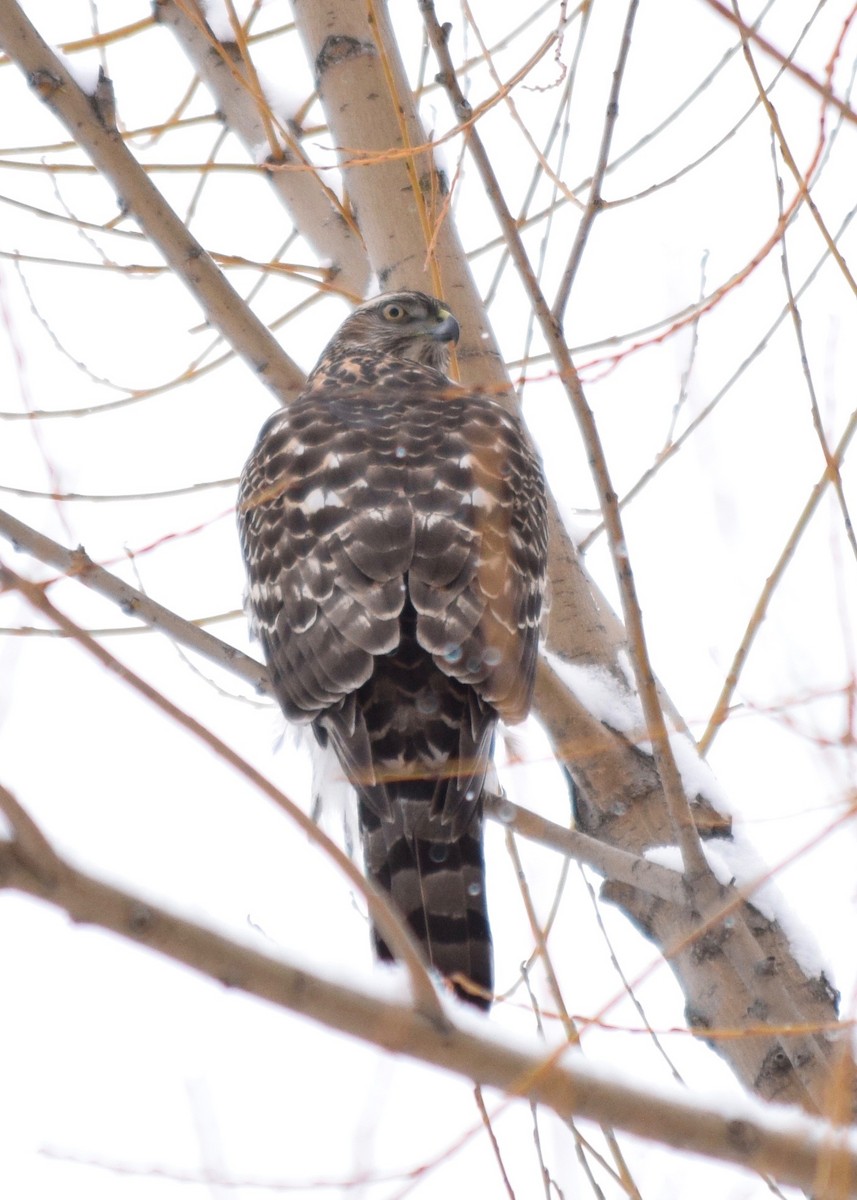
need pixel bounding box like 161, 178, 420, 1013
329, 292, 460, 371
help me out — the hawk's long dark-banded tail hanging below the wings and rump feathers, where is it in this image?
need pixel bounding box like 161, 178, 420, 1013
360, 784, 493, 1009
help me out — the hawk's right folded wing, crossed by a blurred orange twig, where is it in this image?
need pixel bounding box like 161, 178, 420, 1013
409, 396, 547, 722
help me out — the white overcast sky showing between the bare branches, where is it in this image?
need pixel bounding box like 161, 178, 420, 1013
0, 0, 857, 1200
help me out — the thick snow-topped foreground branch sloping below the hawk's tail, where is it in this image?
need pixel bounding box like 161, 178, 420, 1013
0, 842, 857, 1200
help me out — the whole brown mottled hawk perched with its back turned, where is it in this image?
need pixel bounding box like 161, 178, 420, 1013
238, 292, 547, 1008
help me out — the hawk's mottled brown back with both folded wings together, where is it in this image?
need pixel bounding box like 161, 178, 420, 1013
239, 391, 546, 721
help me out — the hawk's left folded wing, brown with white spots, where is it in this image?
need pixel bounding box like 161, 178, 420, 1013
238, 396, 413, 721
